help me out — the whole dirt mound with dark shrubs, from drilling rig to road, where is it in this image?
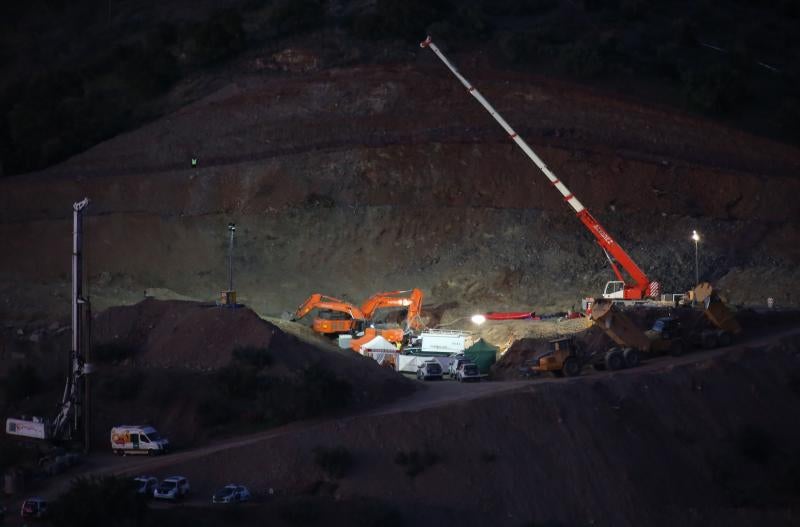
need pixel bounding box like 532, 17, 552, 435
87, 299, 413, 448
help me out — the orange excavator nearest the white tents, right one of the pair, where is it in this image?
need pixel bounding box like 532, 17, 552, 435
350, 288, 424, 352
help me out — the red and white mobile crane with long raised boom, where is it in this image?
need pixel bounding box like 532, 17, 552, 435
420, 36, 661, 301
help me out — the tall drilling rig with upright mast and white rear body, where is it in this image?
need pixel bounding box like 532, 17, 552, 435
6, 198, 91, 451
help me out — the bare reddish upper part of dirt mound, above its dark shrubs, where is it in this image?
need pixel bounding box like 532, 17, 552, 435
94, 299, 406, 383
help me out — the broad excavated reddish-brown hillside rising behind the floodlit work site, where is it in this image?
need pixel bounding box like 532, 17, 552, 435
0, 48, 800, 321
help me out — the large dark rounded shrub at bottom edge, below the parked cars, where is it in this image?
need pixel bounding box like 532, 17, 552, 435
50, 476, 147, 527
